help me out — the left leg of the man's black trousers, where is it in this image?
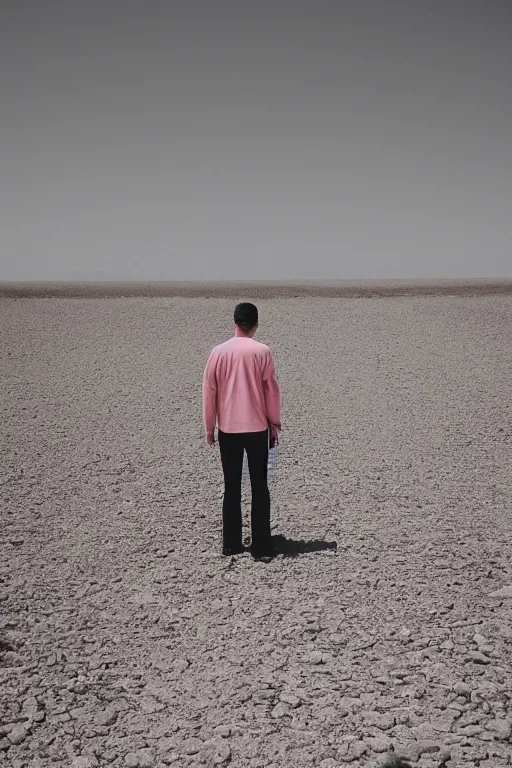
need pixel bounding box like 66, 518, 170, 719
218, 429, 244, 551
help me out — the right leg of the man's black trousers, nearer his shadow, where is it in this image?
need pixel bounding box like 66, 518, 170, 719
245, 429, 271, 554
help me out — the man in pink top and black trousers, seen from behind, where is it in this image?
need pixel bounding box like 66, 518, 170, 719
203, 303, 281, 558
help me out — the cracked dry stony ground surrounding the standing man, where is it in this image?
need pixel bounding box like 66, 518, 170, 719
0, 296, 512, 768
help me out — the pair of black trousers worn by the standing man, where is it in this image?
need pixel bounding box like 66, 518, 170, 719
218, 429, 271, 553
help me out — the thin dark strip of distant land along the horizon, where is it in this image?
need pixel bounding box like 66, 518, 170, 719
0, 278, 512, 299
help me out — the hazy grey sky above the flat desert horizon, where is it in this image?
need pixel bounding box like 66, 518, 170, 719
0, 0, 512, 280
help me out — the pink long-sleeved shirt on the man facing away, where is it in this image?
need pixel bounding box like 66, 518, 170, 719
203, 336, 281, 434
